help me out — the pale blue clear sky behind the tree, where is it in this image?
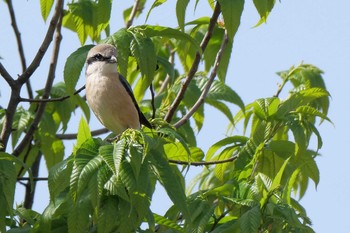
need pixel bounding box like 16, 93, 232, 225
0, 0, 350, 233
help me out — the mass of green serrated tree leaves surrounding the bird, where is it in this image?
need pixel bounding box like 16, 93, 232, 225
0, 0, 331, 233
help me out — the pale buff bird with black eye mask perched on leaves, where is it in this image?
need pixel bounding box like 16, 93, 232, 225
85, 44, 152, 135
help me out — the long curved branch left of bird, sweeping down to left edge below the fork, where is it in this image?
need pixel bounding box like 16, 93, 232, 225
13, 10, 63, 156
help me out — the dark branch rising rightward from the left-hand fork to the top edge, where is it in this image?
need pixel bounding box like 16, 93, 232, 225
18, 0, 64, 84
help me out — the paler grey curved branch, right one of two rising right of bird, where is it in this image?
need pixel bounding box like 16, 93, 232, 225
174, 30, 228, 128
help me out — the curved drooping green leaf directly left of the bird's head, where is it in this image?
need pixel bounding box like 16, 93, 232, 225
63, 45, 94, 95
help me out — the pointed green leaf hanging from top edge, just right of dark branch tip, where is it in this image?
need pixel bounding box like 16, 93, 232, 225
218, 0, 244, 41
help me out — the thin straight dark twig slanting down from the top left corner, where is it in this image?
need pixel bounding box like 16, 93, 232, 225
7, 0, 33, 98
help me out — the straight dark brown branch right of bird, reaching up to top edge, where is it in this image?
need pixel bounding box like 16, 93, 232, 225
164, 2, 221, 122
